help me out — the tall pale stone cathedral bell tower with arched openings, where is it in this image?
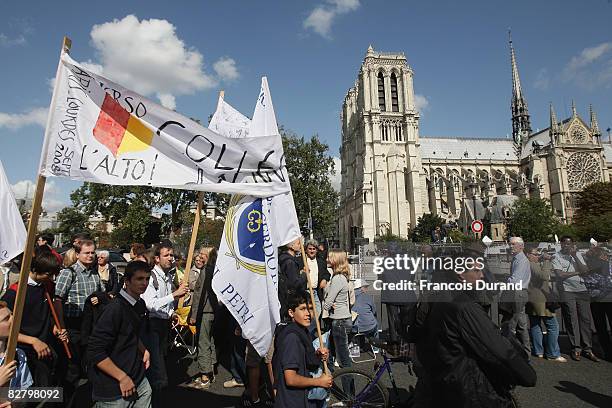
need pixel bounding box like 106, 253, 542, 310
339, 46, 423, 248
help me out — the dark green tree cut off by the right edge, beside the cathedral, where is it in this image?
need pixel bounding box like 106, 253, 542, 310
574, 182, 612, 241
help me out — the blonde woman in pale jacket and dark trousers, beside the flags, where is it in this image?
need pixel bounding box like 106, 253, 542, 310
323, 249, 353, 378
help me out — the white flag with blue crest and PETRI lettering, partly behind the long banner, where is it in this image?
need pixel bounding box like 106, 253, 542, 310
211, 77, 301, 356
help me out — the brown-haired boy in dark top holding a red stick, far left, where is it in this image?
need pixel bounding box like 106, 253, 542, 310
2, 250, 68, 387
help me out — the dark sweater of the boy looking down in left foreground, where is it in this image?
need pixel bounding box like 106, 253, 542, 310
87, 294, 147, 401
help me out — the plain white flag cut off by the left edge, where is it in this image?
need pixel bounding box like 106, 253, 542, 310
0, 161, 26, 264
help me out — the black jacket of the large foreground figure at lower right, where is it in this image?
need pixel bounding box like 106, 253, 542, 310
416, 292, 536, 408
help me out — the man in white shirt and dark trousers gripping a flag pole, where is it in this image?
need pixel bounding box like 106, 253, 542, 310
142, 241, 188, 406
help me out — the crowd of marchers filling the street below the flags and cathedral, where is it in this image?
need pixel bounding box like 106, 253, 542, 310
0, 230, 612, 408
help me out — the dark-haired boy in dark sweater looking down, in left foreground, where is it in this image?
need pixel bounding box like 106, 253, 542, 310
87, 261, 151, 408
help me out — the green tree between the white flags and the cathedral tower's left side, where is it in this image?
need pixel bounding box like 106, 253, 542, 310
280, 128, 338, 238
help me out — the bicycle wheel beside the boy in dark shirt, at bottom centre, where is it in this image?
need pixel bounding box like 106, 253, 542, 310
328, 367, 389, 408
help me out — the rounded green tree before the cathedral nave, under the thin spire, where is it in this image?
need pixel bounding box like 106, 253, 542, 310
506, 198, 559, 242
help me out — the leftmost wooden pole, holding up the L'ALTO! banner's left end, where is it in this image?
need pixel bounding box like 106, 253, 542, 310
4, 37, 72, 365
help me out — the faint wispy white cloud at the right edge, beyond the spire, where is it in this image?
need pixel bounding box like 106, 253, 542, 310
561, 42, 612, 89
